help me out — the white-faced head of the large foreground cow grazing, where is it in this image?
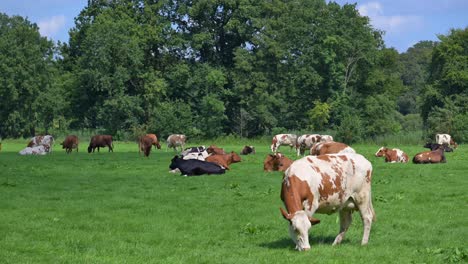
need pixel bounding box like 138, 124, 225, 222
280, 208, 320, 251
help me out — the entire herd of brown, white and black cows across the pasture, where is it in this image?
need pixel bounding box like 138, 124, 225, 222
9, 134, 457, 251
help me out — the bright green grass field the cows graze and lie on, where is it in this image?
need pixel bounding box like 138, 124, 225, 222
0, 139, 468, 264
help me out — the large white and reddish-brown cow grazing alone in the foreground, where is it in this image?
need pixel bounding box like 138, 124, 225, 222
280, 153, 375, 251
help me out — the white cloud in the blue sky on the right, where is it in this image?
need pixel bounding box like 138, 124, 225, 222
358, 2, 423, 33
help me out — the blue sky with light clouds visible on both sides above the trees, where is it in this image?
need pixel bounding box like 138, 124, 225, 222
0, 0, 468, 52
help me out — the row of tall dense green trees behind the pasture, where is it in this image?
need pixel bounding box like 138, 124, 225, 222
0, 0, 468, 143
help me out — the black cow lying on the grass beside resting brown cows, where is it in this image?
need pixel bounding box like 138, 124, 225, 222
169, 156, 226, 176
